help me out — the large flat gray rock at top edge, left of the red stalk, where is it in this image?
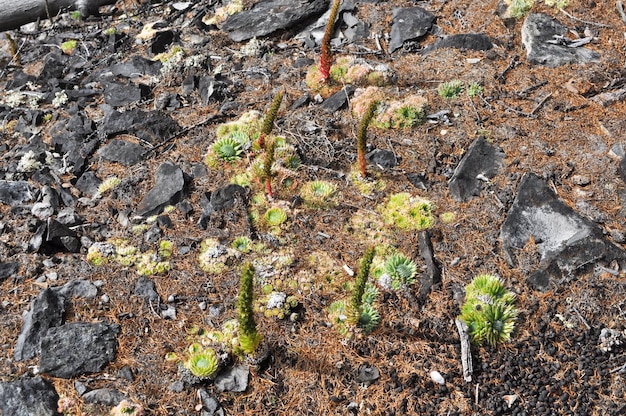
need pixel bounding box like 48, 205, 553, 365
222, 0, 328, 42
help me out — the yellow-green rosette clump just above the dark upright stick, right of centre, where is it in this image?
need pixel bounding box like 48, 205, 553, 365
378, 192, 435, 231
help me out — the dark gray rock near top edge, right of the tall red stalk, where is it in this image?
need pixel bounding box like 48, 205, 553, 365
389, 7, 435, 53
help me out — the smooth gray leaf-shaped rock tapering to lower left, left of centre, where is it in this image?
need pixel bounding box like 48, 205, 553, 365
137, 162, 185, 216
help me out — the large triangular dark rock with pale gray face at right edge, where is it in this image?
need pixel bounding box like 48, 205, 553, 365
500, 173, 626, 288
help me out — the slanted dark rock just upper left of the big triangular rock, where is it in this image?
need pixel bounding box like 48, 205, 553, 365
449, 136, 504, 202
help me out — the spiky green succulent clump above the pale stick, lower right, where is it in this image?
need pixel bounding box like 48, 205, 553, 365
459, 274, 517, 346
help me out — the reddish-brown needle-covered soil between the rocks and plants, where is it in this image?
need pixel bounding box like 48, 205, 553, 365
0, 0, 626, 415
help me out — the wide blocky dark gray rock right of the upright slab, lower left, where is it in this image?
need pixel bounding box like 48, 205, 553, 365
39, 322, 120, 378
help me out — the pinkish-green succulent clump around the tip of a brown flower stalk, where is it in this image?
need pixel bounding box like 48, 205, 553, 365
351, 86, 428, 129
